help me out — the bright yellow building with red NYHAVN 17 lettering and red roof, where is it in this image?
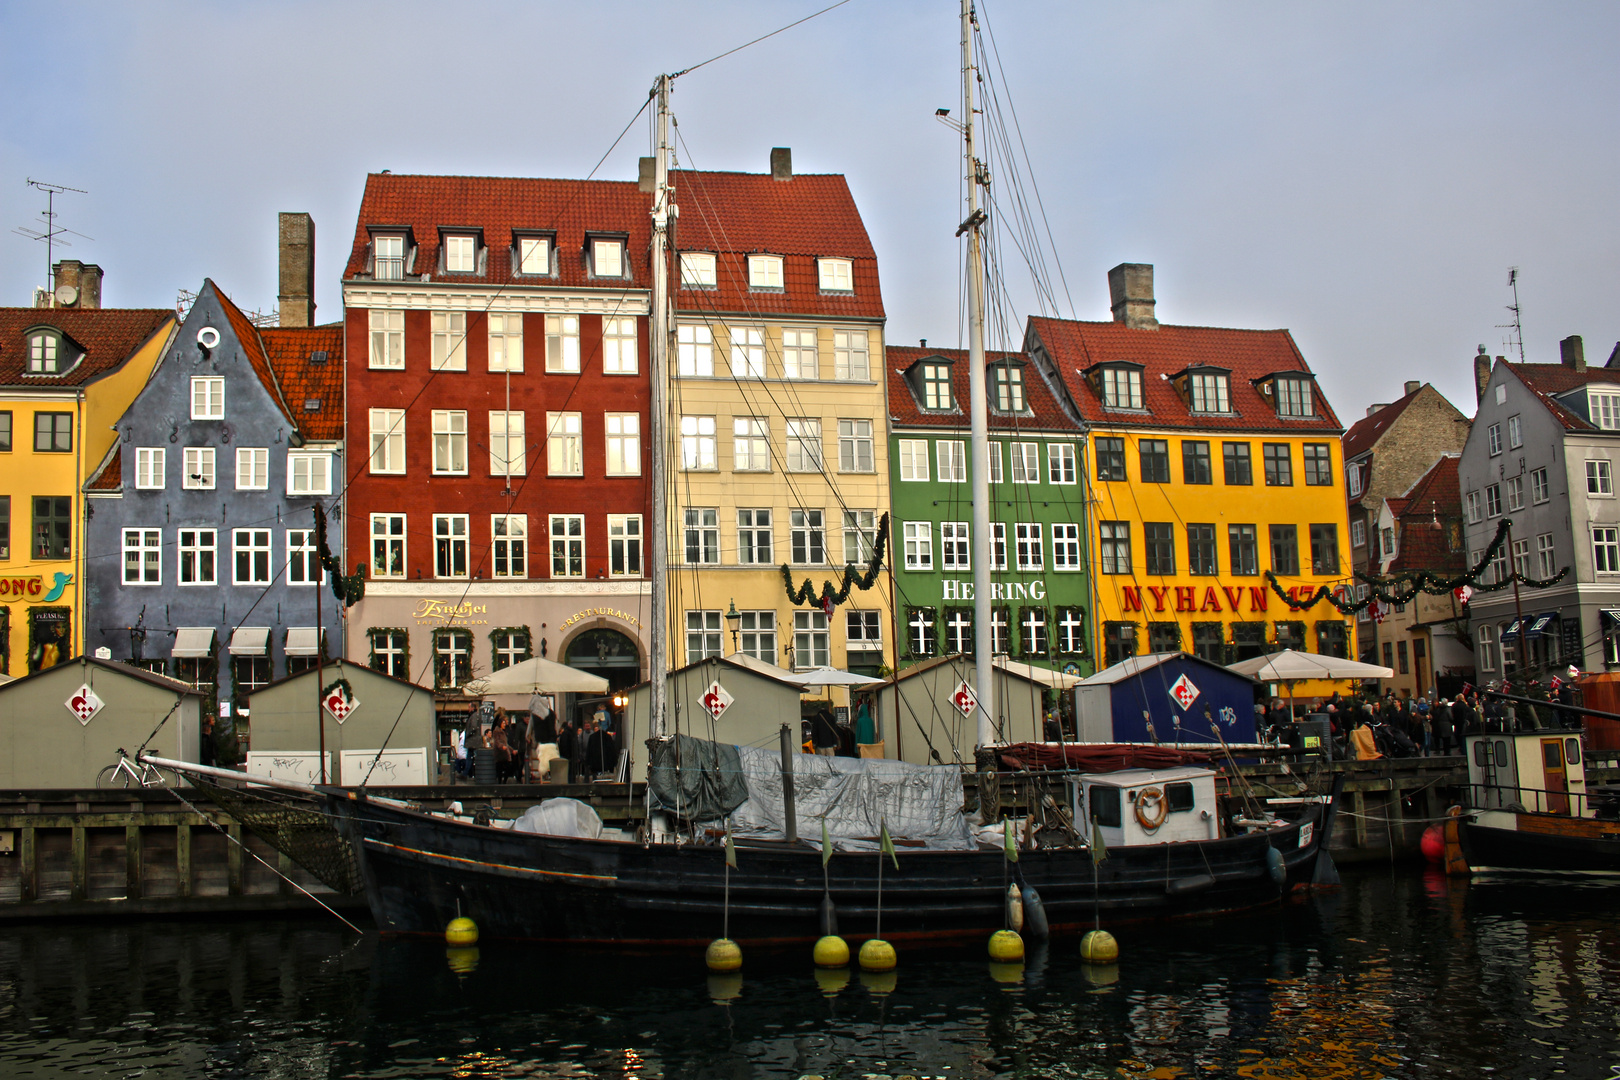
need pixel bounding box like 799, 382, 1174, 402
1025, 264, 1351, 676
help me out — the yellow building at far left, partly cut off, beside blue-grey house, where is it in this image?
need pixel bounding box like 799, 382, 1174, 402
0, 281, 175, 675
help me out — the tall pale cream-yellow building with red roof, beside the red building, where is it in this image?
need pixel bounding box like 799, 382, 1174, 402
667, 158, 894, 703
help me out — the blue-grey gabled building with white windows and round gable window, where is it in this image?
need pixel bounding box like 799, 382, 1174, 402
84, 265, 343, 744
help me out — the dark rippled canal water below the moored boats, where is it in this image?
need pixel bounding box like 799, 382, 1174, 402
0, 866, 1620, 1080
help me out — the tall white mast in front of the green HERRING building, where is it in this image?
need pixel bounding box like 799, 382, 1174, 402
957, 0, 996, 746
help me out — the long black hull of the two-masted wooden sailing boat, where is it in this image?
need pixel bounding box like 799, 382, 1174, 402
329, 795, 1325, 947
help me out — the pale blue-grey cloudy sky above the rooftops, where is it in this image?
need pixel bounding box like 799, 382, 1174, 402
0, 0, 1620, 424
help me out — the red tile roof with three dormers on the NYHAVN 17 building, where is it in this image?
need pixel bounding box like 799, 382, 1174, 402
1029, 316, 1341, 434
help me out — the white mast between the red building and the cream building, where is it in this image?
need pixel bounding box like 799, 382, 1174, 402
646, 74, 676, 738
